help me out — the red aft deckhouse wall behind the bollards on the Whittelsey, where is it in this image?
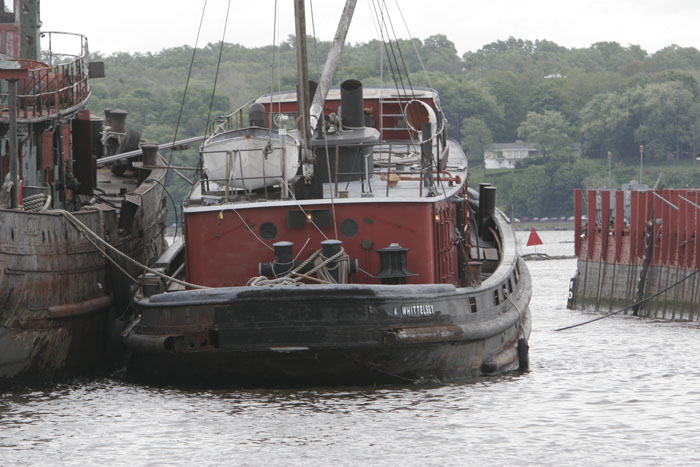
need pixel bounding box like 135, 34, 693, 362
185, 201, 459, 287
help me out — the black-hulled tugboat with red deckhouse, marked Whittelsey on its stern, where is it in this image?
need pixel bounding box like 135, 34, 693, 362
123, 0, 531, 386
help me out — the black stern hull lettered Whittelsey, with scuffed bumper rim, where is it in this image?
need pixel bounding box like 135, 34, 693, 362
125, 267, 530, 386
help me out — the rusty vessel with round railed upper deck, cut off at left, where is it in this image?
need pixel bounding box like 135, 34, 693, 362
0, 0, 167, 382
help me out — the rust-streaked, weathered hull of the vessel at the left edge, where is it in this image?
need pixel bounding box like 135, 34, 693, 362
0, 169, 165, 381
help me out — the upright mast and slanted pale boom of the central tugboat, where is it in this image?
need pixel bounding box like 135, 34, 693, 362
294, 0, 357, 183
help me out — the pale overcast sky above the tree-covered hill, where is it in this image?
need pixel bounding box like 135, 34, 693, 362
41, 0, 700, 55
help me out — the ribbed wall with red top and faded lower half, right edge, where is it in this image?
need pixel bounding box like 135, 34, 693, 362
574, 189, 700, 320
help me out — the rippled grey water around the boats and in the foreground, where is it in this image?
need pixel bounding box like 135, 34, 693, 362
0, 232, 700, 466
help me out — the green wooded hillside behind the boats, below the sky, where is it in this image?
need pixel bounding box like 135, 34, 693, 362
89, 34, 700, 221
